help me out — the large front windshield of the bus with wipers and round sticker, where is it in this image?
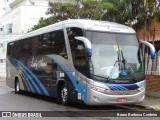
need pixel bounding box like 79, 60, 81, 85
86, 31, 144, 80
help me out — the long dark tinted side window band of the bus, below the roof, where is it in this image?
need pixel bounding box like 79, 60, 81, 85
7, 30, 68, 59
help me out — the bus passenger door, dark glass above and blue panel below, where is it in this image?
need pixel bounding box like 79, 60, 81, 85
67, 27, 89, 103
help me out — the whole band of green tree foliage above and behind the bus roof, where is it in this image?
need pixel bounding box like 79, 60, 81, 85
31, 0, 160, 31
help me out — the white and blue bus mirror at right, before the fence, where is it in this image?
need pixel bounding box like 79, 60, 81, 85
140, 41, 156, 59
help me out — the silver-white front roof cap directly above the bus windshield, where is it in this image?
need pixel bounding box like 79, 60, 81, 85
65, 19, 135, 33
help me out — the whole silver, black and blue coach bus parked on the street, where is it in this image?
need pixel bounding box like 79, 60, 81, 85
6, 19, 155, 105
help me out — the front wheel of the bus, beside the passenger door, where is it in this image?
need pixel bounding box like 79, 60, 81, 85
61, 84, 69, 105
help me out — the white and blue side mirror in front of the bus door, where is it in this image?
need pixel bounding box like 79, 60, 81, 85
74, 36, 92, 57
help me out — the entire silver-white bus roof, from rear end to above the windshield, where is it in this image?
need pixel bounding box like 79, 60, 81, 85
10, 19, 136, 42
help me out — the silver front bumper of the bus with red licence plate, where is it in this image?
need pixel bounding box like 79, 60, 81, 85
87, 88, 145, 105
